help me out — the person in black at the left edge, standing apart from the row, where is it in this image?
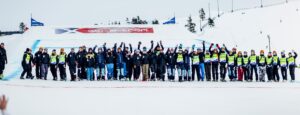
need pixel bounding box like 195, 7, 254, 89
0, 43, 7, 80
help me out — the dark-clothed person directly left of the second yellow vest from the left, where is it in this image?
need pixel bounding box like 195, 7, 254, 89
41, 48, 50, 80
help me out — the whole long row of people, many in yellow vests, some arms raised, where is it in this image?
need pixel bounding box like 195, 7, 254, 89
21, 41, 297, 82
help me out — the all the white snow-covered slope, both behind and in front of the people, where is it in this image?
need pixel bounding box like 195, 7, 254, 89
0, 2, 300, 115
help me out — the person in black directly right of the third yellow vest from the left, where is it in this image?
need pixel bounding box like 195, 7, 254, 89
67, 48, 76, 81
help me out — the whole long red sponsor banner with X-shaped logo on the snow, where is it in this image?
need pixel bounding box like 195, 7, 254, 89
55, 27, 154, 34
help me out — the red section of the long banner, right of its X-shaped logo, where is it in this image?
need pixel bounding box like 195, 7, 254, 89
76, 27, 154, 33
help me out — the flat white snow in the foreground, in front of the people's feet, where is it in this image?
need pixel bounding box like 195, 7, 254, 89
0, 80, 300, 115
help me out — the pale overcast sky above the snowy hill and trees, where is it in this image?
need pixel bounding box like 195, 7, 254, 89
0, 0, 285, 30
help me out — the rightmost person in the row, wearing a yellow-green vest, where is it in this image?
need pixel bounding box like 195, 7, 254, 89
287, 50, 298, 82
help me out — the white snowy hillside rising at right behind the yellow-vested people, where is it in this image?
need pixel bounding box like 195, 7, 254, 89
199, 1, 300, 52
